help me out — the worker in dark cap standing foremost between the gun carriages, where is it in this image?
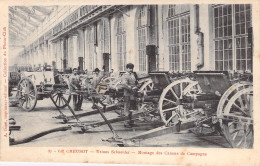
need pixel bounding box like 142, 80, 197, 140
121, 63, 137, 128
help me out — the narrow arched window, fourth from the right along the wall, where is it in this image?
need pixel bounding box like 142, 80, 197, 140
116, 15, 126, 71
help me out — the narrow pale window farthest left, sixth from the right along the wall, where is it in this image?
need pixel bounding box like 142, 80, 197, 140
85, 26, 95, 71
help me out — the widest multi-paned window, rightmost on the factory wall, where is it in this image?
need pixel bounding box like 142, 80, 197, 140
214, 4, 252, 70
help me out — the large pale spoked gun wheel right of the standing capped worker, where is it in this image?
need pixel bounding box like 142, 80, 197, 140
159, 78, 199, 126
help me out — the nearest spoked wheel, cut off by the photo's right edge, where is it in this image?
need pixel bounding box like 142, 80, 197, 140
221, 86, 254, 148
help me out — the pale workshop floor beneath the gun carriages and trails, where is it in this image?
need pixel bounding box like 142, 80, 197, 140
9, 93, 229, 148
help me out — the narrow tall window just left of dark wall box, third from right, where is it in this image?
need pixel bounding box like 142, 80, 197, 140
136, 6, 148, 71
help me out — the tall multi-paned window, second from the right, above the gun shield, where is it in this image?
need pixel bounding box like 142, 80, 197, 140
167, 5, 191, 71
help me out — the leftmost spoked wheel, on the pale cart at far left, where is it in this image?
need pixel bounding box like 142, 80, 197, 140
17, 77, 37, 111
